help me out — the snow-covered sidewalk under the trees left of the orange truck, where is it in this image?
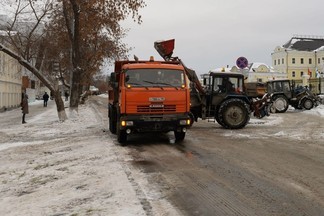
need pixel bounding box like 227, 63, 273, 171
0, 98, 162, 216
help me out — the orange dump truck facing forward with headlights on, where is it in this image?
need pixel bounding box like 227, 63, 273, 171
108, 57, 190, 144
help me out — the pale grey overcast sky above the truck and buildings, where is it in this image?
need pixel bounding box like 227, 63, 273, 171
117, 0, 324, 73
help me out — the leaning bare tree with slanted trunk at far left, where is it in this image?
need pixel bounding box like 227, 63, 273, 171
0, 0, 67, 121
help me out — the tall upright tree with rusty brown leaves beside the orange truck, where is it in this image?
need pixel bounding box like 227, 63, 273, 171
60, 0, 145, 113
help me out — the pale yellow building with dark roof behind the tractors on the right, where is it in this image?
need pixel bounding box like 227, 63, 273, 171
271, 35, 324, 80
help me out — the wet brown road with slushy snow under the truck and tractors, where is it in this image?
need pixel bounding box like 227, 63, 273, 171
92, 96, 324, 216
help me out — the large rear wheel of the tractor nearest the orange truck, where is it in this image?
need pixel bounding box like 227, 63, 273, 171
218, 98, 250, 129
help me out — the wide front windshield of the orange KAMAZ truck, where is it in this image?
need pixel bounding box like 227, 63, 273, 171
125, 68, 185, 88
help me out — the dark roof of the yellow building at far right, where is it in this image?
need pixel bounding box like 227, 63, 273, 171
283, 36, 324, 51
